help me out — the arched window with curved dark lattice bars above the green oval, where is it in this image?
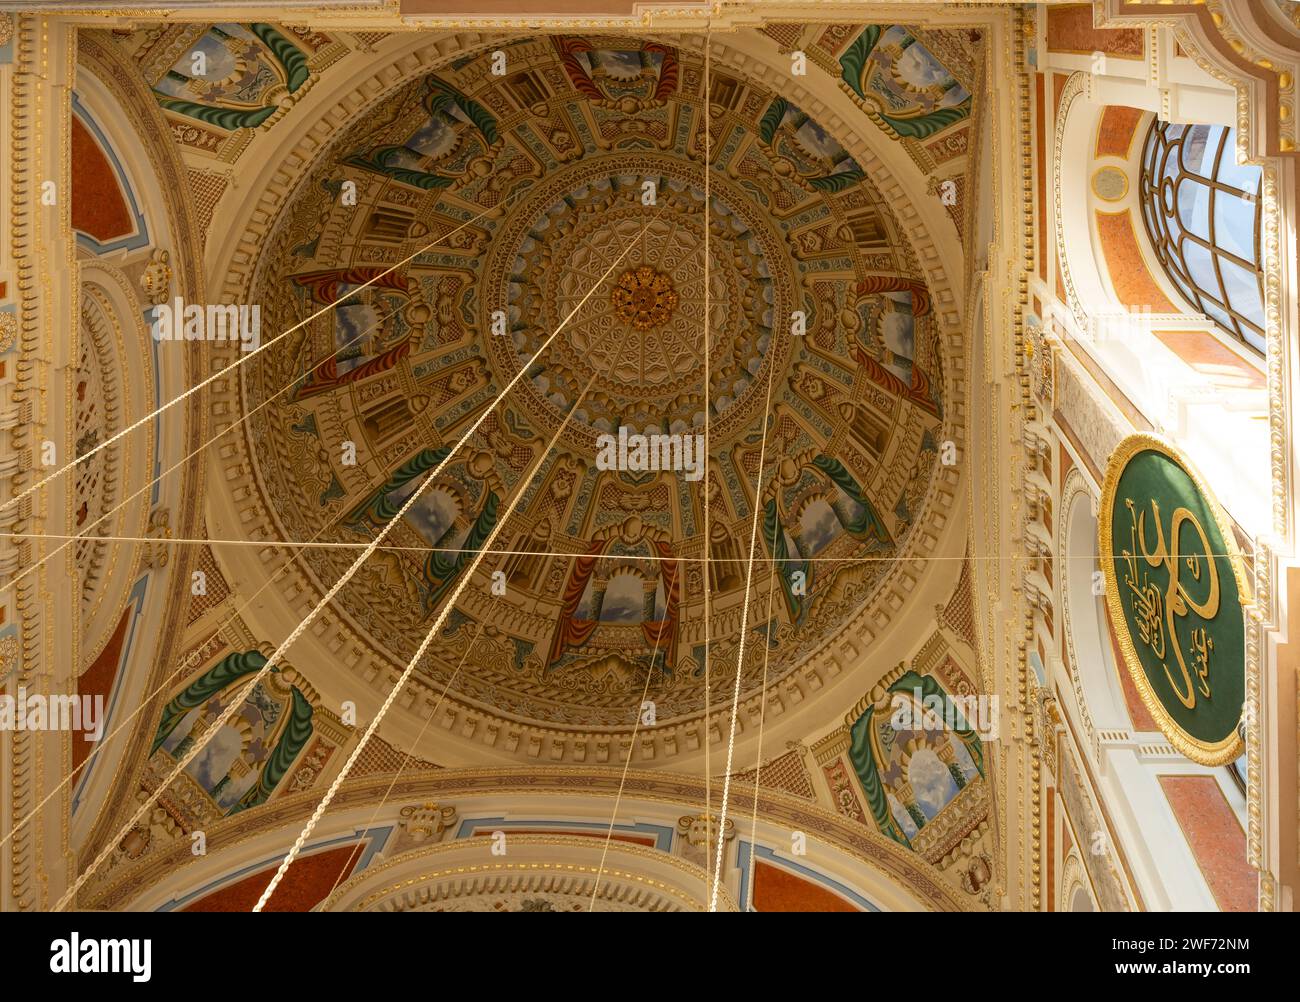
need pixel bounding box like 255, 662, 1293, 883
1141, 121, 1264, 353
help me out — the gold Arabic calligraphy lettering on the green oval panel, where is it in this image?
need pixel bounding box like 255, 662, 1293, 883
1121, 498, 1219, 710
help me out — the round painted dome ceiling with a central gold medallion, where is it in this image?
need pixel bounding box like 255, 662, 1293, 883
242, 38, 944, 726
